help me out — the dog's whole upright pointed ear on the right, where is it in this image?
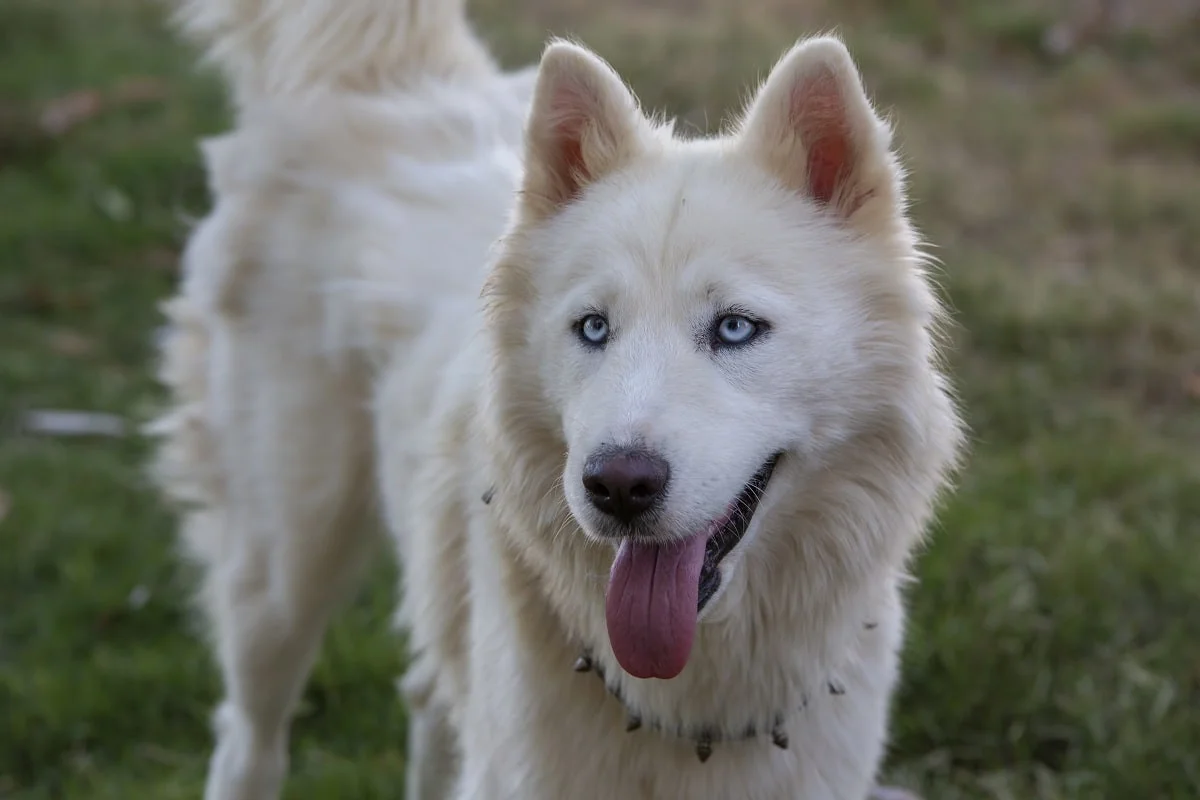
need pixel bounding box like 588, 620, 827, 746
742, 36, 900, 219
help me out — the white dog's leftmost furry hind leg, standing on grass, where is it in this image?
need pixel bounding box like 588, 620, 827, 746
176, 339, 376, 800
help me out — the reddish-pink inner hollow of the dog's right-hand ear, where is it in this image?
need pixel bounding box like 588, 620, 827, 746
791, 72, 854, 204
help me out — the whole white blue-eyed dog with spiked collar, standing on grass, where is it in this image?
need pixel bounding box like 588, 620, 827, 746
152, 0, 961, 800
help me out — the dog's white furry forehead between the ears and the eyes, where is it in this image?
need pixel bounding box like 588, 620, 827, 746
545, 160, 848, 306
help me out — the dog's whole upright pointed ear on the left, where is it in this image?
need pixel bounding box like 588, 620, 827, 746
522, 41, 650, 217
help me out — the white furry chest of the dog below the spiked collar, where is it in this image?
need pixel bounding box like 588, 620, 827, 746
460, 607, 882, 800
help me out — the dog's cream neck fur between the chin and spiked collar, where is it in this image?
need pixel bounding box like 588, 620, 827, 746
481, 479, 894, 762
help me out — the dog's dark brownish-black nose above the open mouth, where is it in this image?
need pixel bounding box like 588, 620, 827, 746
583, 447, 671, 524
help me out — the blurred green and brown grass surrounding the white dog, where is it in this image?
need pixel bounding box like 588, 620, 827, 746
0, 0, 1200, 800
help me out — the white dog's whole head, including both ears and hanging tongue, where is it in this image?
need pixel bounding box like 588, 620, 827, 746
487, 38, 954, 676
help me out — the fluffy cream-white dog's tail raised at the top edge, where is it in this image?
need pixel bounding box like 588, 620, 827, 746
175, 0, 493, 100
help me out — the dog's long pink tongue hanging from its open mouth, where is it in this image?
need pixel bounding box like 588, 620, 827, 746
605, 536, 708, 678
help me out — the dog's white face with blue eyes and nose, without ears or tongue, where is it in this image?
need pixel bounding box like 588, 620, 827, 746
540, 159, 888, 542
